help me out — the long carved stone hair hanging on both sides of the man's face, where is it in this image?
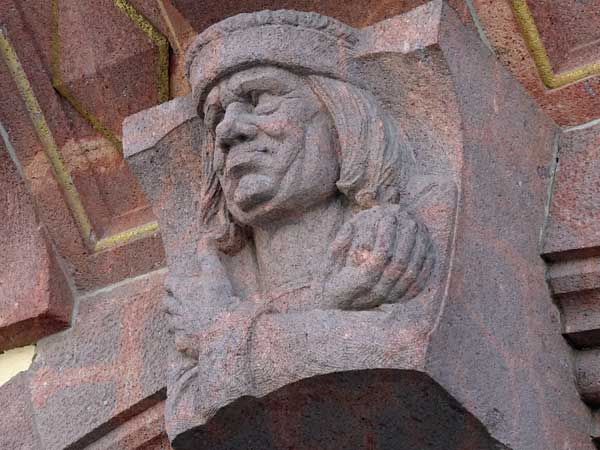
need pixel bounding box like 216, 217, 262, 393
200, 75, 415, 254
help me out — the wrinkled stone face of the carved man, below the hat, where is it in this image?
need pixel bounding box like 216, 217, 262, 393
204, 66, 339, 229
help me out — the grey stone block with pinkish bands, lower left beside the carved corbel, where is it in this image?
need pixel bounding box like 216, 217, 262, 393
31, 272, 167, 450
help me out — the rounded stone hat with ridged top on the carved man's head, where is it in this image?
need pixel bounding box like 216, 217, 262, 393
186, 10, 359, 116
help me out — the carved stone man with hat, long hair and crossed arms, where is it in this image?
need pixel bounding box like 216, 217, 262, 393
157, 11, 456, 448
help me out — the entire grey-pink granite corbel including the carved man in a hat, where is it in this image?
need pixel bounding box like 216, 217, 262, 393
124, 2, 592, 450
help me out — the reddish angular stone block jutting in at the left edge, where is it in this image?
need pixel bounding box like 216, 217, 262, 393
0, 137, 73, 351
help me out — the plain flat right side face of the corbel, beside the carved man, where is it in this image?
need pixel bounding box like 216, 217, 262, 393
430, 2, 592, 449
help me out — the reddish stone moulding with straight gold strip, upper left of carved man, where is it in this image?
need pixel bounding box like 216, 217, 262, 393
0, 0, 164, 291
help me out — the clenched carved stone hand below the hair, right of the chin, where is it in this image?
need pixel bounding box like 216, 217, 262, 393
322, 206, 435, 310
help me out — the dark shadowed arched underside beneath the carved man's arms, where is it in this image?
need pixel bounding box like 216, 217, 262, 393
173, 369, 506, 450
